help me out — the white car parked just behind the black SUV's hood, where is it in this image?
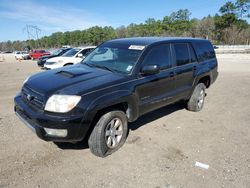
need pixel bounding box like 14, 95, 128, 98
44, 46, 96, 70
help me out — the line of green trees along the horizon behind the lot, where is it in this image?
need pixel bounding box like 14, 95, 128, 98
0, 0, 250, 51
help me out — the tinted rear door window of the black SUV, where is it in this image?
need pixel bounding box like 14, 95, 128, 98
173, 43, 190, 66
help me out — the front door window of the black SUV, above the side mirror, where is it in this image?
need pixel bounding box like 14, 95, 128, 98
144, 44, 172, 69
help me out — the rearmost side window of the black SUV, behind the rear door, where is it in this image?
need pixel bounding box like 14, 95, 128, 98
194, 41, 215, 61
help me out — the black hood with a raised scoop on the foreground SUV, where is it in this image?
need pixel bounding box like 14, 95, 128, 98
25, 64, 127, 95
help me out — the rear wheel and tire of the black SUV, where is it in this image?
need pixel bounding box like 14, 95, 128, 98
187, 83, 206, 112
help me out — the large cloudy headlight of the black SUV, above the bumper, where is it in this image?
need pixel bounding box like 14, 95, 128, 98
45, 95, 81, 113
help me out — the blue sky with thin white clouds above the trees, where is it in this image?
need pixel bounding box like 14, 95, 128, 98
0, 0, 244, 41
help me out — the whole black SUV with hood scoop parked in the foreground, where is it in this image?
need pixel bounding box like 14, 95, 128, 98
15, 38, 218, 157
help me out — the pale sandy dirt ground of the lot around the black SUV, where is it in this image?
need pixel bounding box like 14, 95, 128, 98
0, 54, 250, 188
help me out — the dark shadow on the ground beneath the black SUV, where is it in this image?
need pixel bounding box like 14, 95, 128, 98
55, 102, 185, 150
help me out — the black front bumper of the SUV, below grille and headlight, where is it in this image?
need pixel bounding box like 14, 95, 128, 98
14, 95, 89, 142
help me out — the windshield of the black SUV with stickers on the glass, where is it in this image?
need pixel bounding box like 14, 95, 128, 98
82, 45, 142, 74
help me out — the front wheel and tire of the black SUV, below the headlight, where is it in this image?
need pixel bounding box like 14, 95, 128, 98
88, 111, 128, 157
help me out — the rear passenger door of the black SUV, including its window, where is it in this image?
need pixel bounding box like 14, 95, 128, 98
171, 43, 197, 99
